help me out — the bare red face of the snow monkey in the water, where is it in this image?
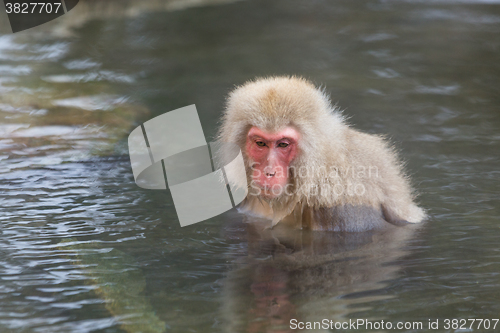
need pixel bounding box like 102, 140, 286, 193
245, 127, 300, 198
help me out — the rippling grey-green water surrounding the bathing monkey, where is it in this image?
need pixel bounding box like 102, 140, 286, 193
0, 0, 500, 332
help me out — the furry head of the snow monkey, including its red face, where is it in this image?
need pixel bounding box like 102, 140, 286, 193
219, 77, 345, 200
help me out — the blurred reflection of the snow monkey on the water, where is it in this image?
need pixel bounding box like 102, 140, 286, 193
223, 217, 417, 333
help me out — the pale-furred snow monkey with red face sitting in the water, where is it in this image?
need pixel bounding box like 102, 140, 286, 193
219, 77, 425, 232
